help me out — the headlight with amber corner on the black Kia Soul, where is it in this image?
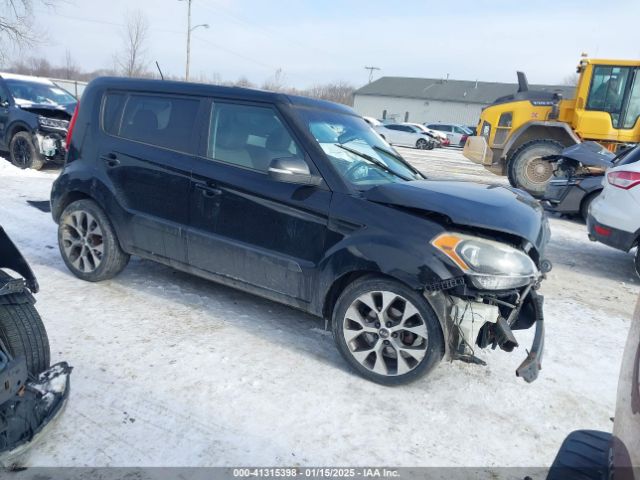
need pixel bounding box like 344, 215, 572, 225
431, 232, 538, 290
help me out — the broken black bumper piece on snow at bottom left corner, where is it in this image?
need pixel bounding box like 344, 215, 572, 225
0, 360, 72, 467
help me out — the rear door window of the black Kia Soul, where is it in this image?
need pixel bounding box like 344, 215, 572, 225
102, 94, 200, 152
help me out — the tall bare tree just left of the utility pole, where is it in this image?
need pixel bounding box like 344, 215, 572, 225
115, 10, 149, 77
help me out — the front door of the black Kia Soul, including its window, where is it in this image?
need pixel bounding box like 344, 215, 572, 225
188, 100, 331, 302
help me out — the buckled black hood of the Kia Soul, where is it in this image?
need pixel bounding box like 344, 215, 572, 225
364, 180, 548, 251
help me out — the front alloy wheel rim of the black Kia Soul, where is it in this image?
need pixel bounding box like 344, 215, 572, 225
342, 291, 429, 376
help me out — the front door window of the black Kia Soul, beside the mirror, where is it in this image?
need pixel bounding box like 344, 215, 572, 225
207, 103, 304, 172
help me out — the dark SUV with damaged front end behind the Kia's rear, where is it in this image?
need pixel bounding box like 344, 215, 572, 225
0, 73, 76, 170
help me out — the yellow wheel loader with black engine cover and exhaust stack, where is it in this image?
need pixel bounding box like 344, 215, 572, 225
464, 58, 640, 197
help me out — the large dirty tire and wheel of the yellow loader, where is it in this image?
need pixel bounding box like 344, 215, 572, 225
507, 139, 565, 198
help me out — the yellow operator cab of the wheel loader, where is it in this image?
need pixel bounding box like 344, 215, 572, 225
572, 59, 640, 146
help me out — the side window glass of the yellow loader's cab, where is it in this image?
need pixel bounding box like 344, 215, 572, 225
587, 65, 632, 127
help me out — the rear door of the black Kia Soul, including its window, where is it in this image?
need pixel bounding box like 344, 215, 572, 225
99, 92, 201, 263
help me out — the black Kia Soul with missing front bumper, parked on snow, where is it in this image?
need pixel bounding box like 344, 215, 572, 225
51, 78, 550, 385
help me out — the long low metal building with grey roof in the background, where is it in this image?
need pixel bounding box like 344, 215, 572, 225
354, 77, 575, 125
